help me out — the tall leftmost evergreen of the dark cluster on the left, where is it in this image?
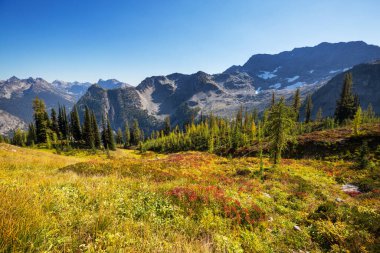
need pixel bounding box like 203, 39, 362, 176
33, 98, 49, 143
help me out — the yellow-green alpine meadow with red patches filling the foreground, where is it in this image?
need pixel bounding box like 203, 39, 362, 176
0, 144, 380, 252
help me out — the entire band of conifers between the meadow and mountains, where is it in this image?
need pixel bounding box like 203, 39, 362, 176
0, 73, 375, 163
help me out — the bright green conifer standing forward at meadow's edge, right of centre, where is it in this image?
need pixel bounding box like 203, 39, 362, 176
267, 98, 295, 164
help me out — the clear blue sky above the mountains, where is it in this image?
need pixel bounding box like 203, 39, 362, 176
0, 0, 380, 85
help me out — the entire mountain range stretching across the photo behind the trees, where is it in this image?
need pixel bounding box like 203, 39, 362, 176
0, 41, 380, 133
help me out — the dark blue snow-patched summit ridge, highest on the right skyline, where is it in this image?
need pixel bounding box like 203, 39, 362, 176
225, 41, 380, 89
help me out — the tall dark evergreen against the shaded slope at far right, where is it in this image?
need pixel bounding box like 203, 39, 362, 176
335, 73, 359, 123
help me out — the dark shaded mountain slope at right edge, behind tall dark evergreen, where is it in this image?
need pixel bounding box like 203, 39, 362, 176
312, 61, 380, 116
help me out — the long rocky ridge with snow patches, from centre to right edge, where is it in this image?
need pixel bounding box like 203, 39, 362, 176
75, 41, 380, 130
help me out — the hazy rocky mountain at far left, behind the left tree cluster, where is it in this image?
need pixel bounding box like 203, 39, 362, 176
0, 76, 75, 134
